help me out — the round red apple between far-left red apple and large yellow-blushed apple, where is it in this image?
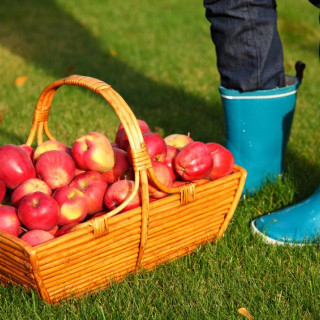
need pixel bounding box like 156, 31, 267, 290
36, 150, 76, 190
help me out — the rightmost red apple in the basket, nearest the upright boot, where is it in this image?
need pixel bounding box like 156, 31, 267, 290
207, 142, 234, 180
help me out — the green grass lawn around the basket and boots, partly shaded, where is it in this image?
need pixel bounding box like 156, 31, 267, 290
0, 0, 320, 320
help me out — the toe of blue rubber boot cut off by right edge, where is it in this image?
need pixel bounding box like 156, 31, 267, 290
251, 187, 320, 245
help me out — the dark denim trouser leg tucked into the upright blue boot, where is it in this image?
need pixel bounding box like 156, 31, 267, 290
204, 0, 285, 91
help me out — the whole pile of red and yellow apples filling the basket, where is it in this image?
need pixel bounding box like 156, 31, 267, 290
0, 120, 234, 246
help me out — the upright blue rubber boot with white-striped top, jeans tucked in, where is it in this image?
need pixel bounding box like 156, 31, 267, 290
219, 76, 302, 194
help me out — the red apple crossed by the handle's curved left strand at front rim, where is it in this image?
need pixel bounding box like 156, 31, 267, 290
104, 180, 141, 212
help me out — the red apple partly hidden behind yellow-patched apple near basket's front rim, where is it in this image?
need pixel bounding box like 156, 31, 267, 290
69, 171, 108, 214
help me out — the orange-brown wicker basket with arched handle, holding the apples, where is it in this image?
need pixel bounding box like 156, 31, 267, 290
0, 75, 246, 303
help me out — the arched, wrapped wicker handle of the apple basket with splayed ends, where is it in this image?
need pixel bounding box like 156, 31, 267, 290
26, 75, 194, 201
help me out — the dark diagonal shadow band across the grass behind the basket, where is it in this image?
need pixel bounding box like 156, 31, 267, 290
0, 0, 224, 143
